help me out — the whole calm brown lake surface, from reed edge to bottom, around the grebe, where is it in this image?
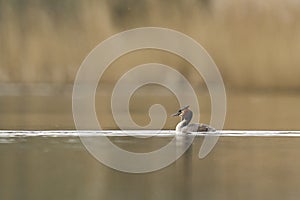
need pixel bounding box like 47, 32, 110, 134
0, 93, 300, 200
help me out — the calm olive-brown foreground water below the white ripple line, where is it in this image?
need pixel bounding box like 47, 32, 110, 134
0, 131, 300, 200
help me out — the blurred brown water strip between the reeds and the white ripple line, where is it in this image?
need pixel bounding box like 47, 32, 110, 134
0, 90, 300, 130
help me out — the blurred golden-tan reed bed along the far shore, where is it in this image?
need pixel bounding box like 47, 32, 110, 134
0, 0, 300, 90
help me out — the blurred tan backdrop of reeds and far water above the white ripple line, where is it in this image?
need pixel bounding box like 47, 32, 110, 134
0, 0, 300, 130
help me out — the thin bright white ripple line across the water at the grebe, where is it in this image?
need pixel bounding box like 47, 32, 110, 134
0, 130, 300, 138
